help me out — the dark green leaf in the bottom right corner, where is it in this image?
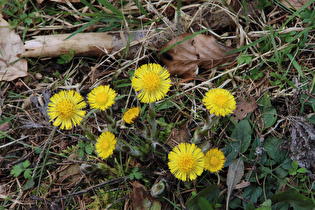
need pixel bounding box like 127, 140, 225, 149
271, 188, 315, 210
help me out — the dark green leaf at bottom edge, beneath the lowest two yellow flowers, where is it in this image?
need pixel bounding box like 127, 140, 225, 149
186, 185, 220, 210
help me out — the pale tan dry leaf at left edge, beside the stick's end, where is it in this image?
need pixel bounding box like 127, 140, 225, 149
0, 15, 27, 81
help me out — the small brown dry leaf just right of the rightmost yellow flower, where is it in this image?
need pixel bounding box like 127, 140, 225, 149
233, 97, 257, 120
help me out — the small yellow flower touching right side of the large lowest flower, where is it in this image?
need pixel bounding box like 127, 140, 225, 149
205, 148, 225, 173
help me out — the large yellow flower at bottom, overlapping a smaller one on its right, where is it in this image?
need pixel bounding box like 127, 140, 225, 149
168, 143, 204, 181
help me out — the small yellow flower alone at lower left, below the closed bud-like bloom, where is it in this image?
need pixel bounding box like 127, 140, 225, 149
95, 131, 117, 159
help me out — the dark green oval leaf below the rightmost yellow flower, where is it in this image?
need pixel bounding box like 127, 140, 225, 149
231, 120, 252, 153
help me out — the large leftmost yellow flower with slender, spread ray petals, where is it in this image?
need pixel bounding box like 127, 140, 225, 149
47, 90, 86, 129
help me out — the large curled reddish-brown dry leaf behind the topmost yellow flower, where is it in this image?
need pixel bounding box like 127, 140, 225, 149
161, 33, 236, 78
